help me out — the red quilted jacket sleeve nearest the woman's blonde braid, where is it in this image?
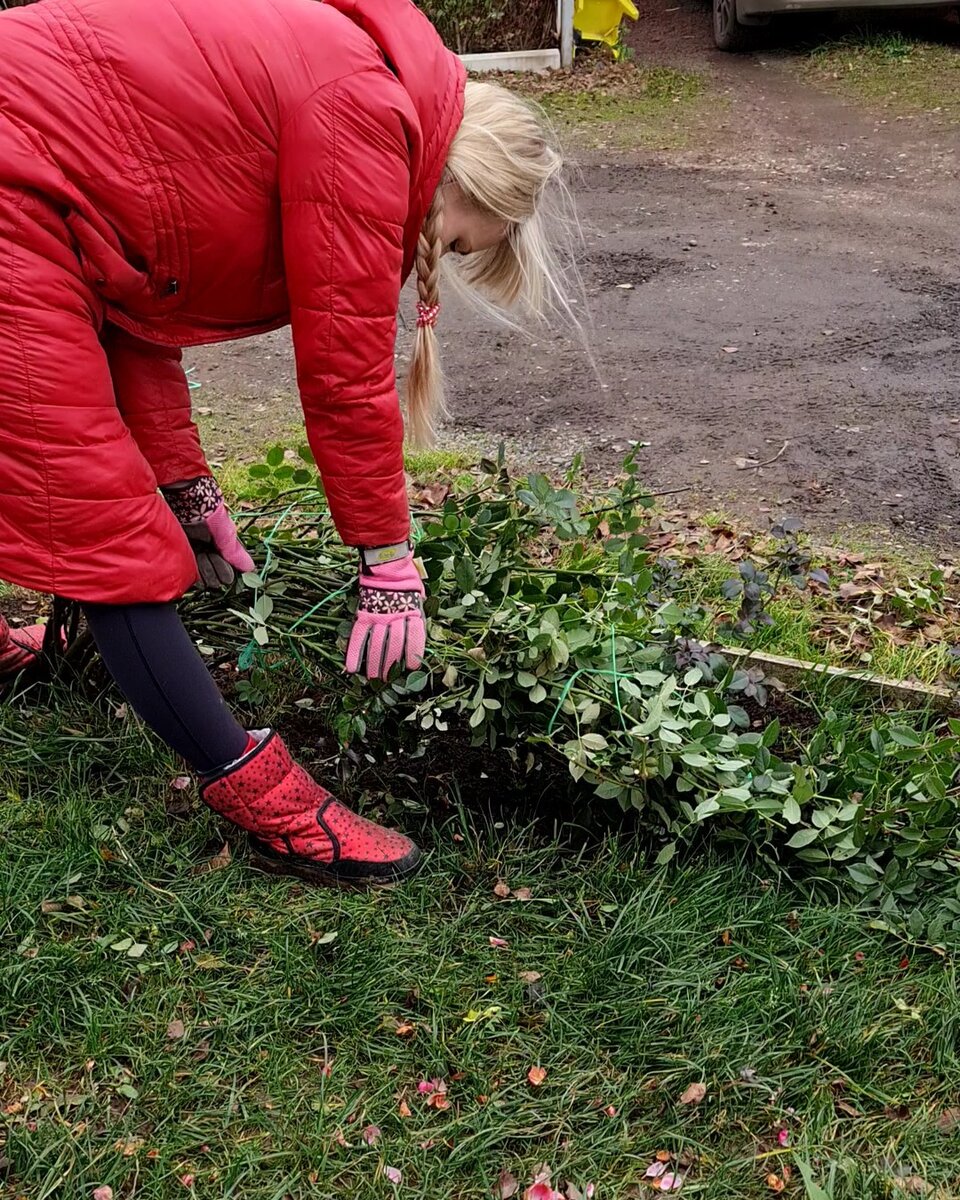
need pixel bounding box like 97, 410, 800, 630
280, 71, 410, 546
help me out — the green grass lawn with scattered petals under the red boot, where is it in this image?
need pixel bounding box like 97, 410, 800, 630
0, 694, 960, 1200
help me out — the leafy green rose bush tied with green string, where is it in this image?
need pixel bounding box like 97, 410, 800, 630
190, 444, 960, 892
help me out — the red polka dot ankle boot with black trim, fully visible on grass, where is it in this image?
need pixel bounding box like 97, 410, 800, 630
200, 730, 420, 887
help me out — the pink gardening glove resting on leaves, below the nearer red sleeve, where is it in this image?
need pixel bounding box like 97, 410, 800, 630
347, 550, 427, 679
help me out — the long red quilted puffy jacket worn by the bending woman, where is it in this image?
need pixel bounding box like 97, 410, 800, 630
0, 0, 463, 602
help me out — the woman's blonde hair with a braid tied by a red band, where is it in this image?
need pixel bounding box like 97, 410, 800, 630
407, 79, 576, 445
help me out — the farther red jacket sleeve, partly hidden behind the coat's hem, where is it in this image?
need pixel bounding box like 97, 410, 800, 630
103, 325, 210, 487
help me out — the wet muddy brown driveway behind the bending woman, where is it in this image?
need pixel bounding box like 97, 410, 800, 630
190, 0, 960, 544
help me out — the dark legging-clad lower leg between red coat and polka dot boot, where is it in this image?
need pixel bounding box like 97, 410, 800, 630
83, 604, 247, 772
